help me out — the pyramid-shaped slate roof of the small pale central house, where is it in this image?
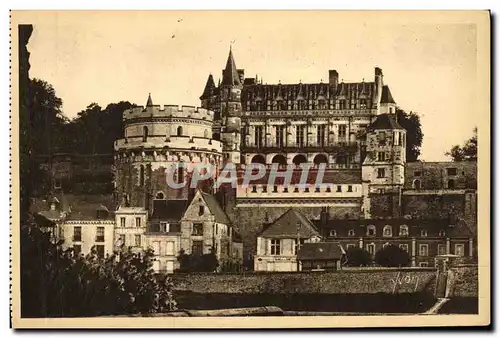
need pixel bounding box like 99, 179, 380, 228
259, 208, 319, 238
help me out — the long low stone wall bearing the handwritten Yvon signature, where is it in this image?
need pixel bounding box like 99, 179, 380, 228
172, 268, 436, 294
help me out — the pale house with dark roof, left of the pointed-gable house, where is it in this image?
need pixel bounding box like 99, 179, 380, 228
145, 199, 188, 273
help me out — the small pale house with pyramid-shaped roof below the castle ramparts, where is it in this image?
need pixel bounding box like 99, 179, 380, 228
254, 208, 321, 271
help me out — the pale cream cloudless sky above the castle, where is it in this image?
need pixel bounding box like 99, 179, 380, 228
26, 11, 479, 161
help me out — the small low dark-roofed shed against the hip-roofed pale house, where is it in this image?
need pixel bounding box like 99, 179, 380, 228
297, 242, 345, 271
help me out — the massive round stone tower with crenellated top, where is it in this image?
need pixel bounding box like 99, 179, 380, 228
115, 95, 222, 210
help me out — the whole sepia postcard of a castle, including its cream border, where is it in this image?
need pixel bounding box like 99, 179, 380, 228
10, 11, 491, 328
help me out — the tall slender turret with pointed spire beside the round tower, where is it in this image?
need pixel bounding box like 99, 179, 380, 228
220, 49, 243, 163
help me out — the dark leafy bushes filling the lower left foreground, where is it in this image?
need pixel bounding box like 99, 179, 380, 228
20, 220, 176, 317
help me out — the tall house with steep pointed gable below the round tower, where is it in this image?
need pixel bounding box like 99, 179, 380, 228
181, 190, 233, 269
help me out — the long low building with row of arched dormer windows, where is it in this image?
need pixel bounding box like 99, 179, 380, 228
315, 217, 475, 267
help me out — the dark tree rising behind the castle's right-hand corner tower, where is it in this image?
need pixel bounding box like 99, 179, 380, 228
396, 108, 424, 162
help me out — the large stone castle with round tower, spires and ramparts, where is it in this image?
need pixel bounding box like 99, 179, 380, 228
111, 50, 477, 262
